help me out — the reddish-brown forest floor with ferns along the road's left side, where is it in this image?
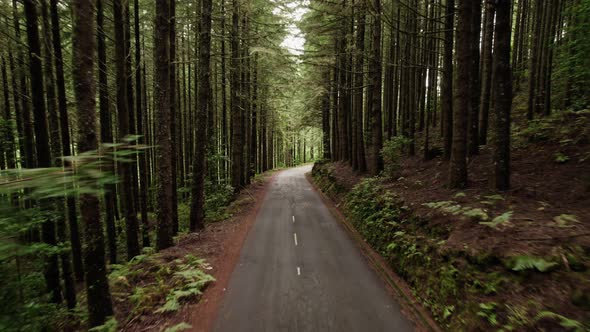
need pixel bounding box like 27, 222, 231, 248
111, 171, 276, 332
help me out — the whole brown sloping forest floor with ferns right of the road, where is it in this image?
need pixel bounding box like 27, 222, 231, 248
314, 112, 590, 331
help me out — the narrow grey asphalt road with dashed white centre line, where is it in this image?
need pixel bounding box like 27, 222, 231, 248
214, 166, 413, 332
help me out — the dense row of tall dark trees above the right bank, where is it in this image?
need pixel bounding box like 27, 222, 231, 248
302, 0, 589, 190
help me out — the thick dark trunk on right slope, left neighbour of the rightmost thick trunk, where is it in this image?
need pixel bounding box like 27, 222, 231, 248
449, 0, 473, 188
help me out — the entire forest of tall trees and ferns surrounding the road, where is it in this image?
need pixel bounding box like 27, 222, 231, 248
0, 0, 590, 331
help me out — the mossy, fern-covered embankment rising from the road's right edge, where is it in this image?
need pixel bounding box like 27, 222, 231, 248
312, 163, 590, 331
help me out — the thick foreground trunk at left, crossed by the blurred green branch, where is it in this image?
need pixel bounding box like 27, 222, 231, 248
73, 0, 113, 327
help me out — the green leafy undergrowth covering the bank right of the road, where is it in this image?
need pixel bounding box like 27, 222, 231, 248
312, 163, 588, 331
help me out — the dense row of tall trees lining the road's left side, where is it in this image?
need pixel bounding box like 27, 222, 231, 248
0, 0, 321, 329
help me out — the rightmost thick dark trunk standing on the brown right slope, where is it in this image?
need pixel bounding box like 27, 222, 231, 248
493, 0, 512, 190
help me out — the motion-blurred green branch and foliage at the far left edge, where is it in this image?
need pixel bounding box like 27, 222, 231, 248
0, 143, 145, 331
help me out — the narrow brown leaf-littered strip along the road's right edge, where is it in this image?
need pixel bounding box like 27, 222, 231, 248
305, 172, 442, 332
